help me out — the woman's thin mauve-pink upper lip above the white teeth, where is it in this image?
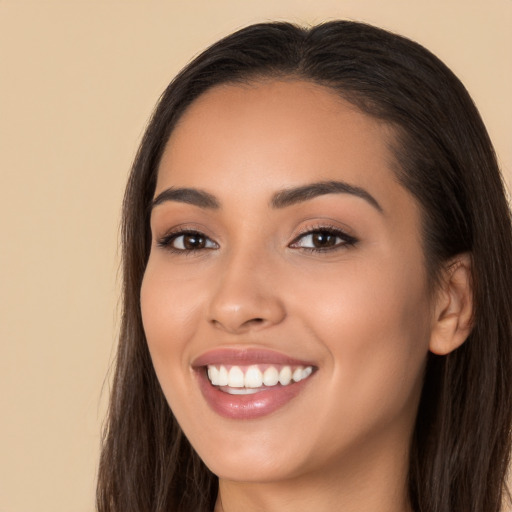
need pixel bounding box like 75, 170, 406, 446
192, 347, 314, 368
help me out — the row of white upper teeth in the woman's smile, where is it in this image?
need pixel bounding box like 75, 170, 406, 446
208, 365, 313, 388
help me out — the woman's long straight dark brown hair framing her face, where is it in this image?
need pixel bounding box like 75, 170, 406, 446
97, 21, 512, 512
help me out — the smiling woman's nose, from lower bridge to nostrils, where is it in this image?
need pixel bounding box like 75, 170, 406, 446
208, 249, 286, 334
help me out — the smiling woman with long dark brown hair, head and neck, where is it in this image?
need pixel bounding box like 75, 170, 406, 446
98, 21, 512, 512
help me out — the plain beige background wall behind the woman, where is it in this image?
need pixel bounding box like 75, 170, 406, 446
0, 0, 512, 512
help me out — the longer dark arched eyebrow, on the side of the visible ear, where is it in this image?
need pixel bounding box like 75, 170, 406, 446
270, 181, 384, 213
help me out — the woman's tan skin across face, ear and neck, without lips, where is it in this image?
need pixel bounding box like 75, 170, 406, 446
141, 80, 471, 512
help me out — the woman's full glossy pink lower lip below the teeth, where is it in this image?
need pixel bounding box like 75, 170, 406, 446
196, 369, 311, 420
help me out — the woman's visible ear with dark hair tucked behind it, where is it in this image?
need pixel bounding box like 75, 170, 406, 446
429, 253, 473, 356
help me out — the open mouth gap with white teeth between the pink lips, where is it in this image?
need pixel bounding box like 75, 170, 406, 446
206, 364, 313, 395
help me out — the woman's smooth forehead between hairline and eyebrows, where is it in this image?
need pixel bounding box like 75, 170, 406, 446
157, 80, 405, 215
